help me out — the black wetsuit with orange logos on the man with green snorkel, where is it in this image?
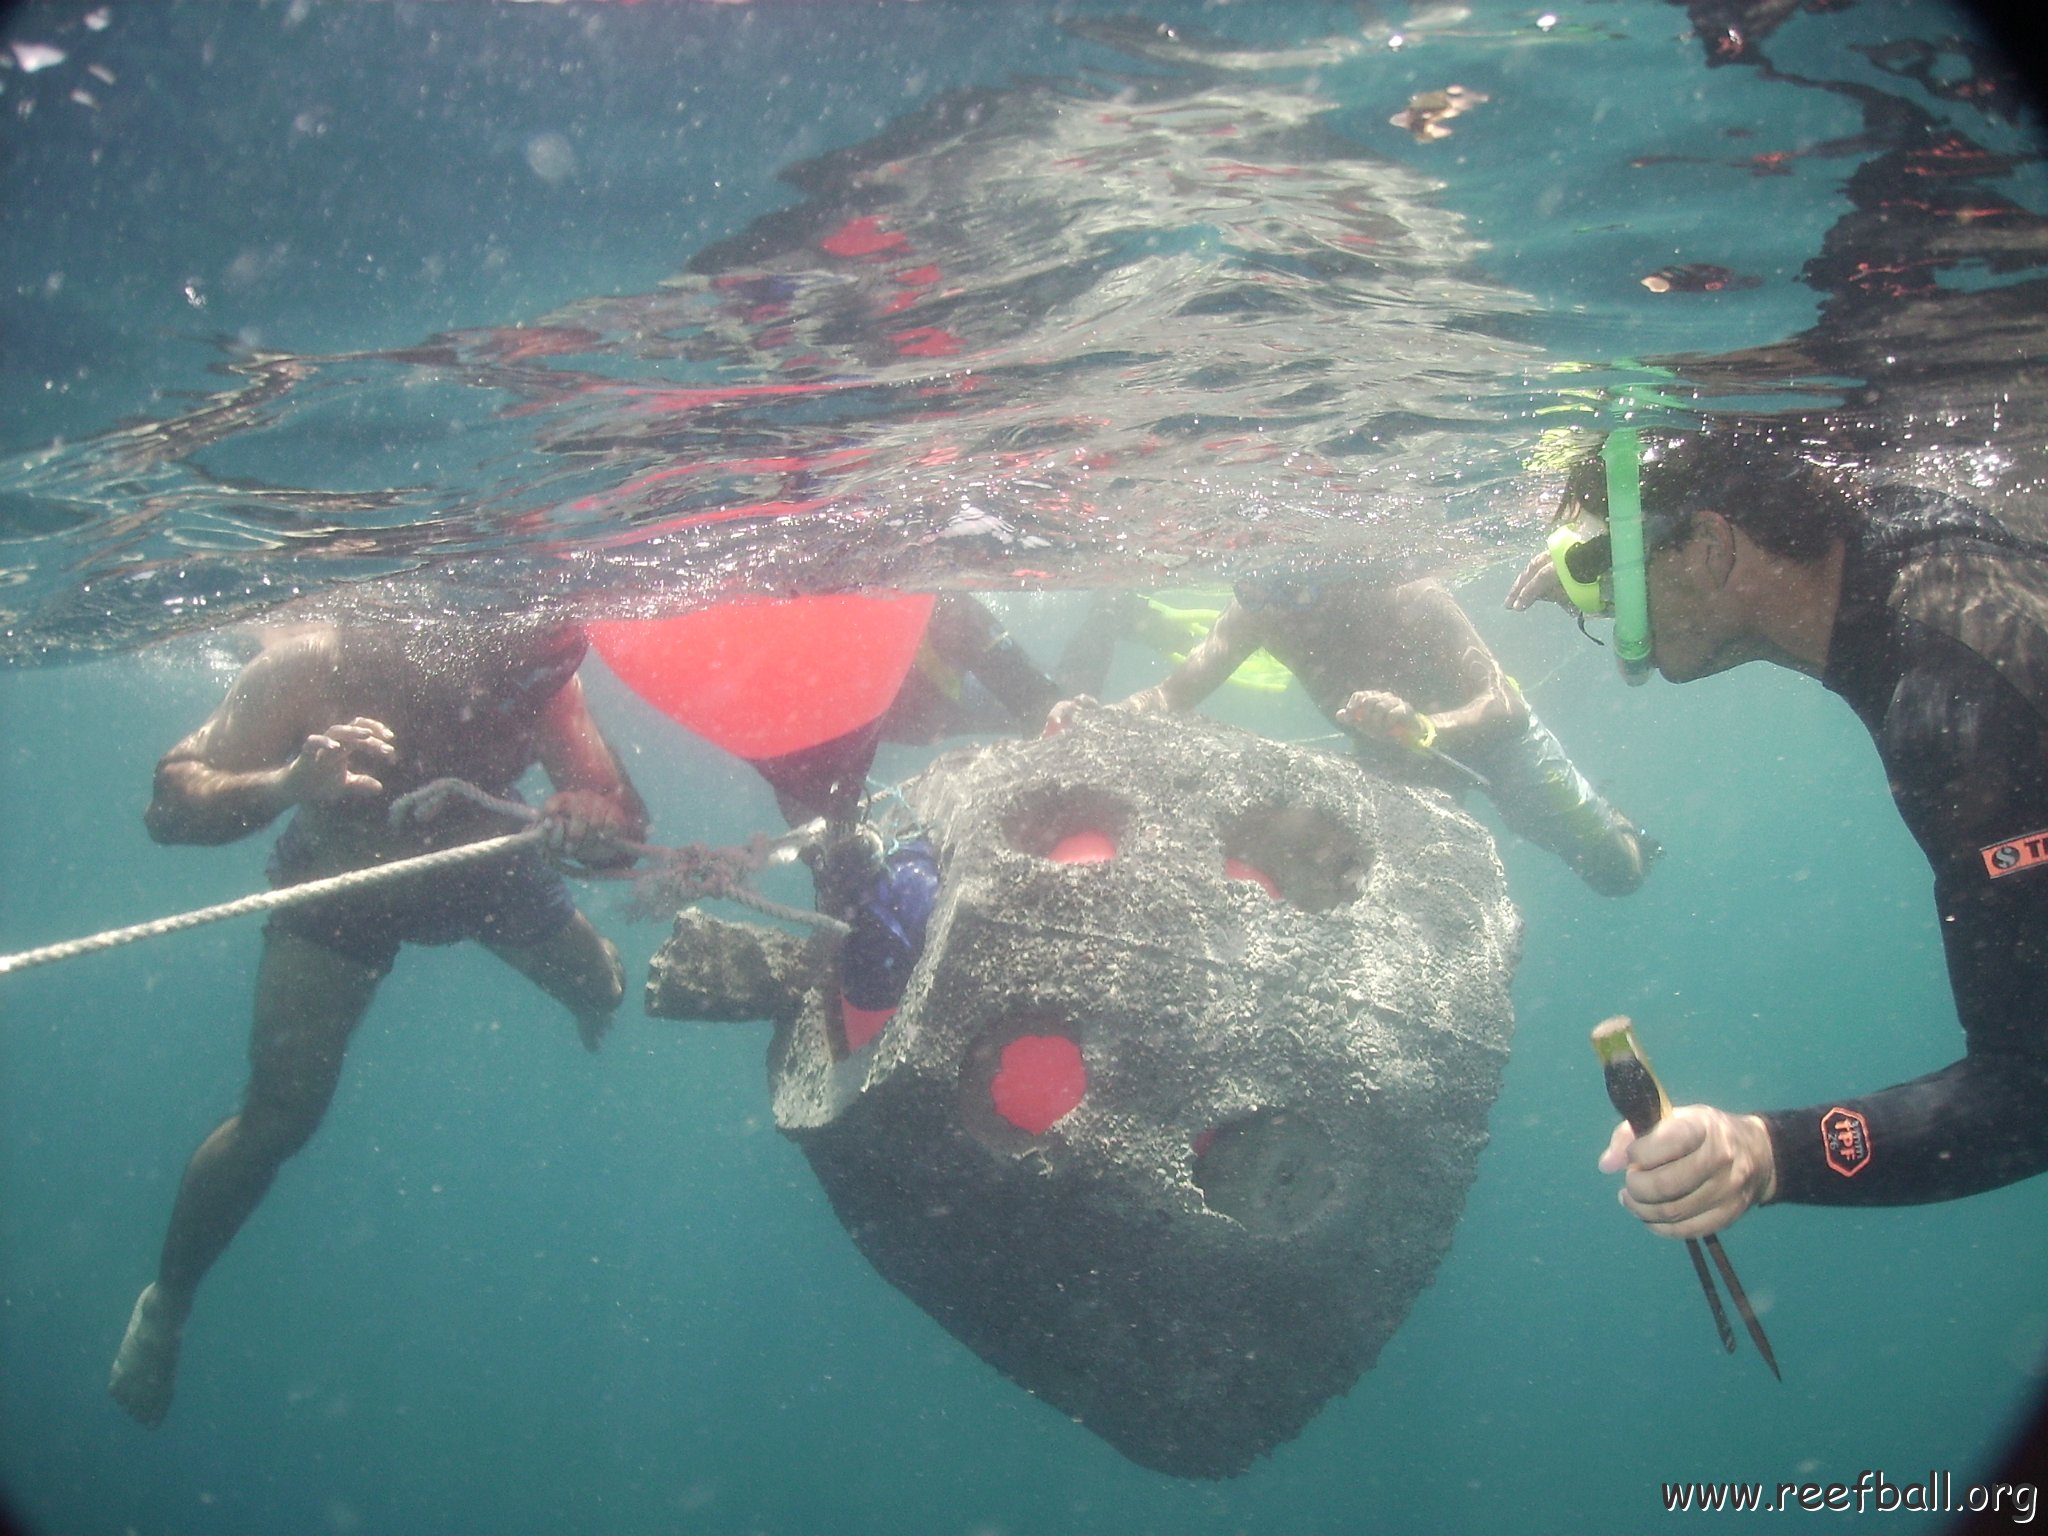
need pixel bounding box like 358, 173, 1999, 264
1763, 487, 2048, 1204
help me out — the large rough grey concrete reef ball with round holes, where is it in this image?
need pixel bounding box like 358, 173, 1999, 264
649, 711, 1520, 1477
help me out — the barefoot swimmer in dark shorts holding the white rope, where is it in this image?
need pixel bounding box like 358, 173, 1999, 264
109, 627, 647, 1425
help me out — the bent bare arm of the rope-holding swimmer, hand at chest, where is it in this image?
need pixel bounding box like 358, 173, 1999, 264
143, 635, 374, 844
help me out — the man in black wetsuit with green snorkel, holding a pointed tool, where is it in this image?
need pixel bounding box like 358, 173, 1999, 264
1509, 428, 2048, 1237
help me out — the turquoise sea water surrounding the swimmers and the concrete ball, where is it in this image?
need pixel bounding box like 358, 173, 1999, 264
0, 4, 2048, 1536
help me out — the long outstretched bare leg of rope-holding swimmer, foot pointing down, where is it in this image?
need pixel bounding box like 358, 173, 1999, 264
106, 930, 385, 1427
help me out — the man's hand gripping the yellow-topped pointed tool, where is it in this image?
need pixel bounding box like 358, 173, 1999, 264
1599, 1104, 1778, 1237
